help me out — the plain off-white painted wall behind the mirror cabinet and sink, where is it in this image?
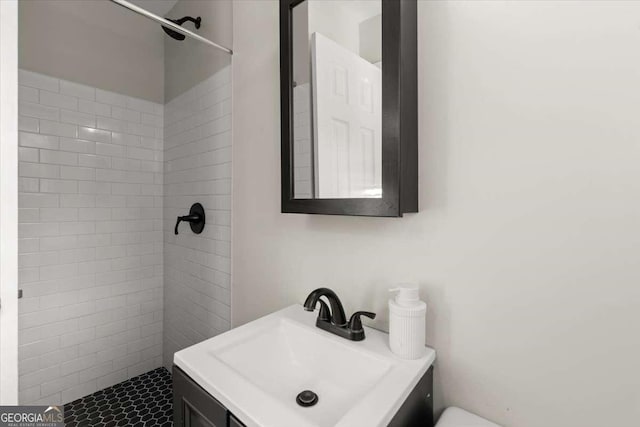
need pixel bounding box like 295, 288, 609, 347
232, 0, 640, 427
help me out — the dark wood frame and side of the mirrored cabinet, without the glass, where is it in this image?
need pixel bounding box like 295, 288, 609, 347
280, 0, 418, 217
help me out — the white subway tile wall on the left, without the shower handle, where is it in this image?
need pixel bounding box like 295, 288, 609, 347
19, 70, 165, 404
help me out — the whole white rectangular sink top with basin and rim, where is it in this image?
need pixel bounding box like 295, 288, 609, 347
174, 305, 435, 427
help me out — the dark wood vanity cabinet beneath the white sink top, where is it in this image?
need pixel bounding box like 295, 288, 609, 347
173, 366, 435, 427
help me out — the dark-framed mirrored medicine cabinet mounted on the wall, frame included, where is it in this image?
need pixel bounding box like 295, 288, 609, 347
280, 0, 418, 216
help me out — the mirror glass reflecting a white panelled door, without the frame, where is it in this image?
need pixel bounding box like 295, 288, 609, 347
292, 0, 382, 199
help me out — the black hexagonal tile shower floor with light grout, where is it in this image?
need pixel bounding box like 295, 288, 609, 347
64, 368, 173, 427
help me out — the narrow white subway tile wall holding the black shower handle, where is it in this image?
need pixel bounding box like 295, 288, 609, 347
162, 67, 231, 367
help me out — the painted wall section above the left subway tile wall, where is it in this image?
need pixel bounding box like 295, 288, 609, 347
19, 0, 166, 102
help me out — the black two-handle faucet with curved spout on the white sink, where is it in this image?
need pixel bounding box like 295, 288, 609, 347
304, 288, 376, 341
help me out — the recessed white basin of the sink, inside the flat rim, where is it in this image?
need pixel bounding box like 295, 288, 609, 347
217, 320, 391, 426
